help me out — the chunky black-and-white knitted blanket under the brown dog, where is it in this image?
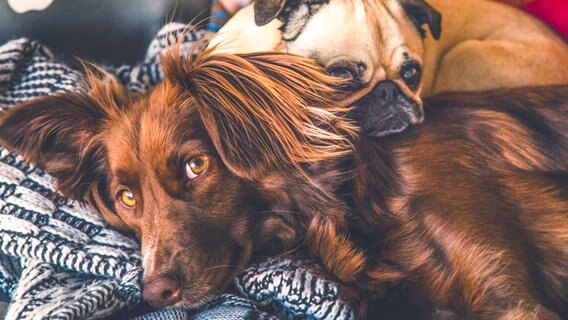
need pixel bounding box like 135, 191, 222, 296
0, 24, 354, 320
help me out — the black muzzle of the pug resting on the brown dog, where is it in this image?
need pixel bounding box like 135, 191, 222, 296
350, 81, 424, 137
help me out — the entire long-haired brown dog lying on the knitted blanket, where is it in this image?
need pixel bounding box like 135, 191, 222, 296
0, 48, 568, 320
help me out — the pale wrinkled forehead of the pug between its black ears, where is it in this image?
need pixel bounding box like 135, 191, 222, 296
287, 0, 421, 62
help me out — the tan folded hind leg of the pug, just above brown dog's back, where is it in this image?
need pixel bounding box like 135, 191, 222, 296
426, 40, 568, 95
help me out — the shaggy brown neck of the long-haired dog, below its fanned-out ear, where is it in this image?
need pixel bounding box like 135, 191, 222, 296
255, 143, 400, 284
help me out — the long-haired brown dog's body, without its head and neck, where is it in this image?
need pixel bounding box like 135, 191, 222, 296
354, 86, 568, 319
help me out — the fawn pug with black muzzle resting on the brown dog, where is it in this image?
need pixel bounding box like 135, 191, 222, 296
212, 0, 568, 136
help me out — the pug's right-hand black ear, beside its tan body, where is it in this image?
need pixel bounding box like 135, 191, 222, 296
400, 0, 442, 40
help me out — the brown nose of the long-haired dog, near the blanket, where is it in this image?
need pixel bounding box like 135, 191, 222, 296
142, 274, 181, 308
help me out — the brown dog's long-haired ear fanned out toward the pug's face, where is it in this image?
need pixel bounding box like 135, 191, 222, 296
163, 52, 355, 179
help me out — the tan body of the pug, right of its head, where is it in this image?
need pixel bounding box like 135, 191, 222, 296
424, 0, 568, 96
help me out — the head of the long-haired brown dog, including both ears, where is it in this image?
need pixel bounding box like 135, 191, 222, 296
0, 53, 353, 307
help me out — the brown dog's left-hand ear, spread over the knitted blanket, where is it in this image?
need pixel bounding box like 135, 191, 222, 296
0, 70, 124, 200
